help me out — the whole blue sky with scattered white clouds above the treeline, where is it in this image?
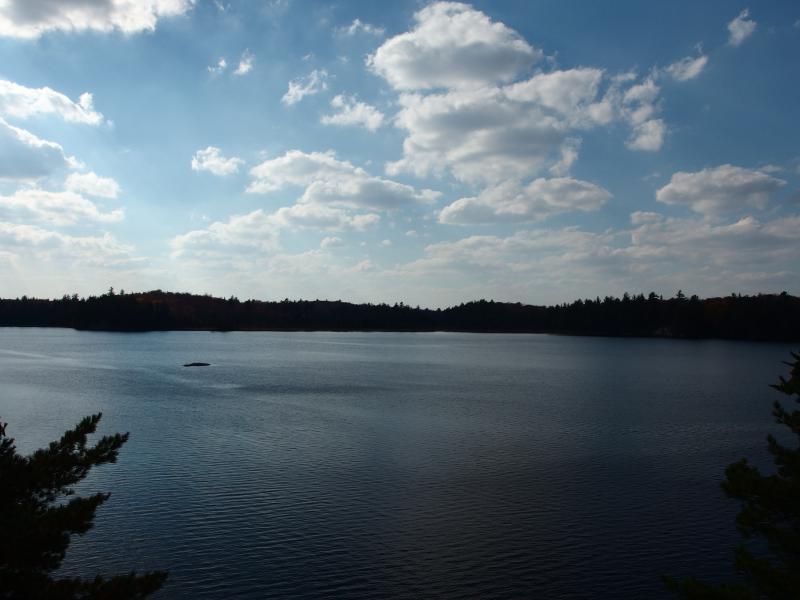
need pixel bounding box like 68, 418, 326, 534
0, 0, 800, 307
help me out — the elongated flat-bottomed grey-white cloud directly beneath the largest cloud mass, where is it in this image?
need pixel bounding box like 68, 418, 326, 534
439, 177, 611, 225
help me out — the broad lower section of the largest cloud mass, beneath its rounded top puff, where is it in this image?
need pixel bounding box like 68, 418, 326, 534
386, 68, 666, 183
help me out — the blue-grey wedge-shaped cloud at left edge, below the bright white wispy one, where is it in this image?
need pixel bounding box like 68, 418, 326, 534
0, 118, 75, 180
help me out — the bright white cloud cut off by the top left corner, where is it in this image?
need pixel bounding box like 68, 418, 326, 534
0, 0, 194, 38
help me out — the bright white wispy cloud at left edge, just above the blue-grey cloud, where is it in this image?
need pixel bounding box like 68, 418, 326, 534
0, 80, 103, 125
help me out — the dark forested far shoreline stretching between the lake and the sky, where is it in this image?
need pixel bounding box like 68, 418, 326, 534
0, 288, 800, 341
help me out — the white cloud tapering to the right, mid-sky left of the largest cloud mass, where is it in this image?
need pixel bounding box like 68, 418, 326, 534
247, 150, 439, 210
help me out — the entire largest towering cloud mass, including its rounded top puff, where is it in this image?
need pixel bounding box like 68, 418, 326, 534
382, 3, 676, 185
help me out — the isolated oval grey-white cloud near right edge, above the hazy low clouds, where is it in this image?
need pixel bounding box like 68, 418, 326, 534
656, 164, 786, 215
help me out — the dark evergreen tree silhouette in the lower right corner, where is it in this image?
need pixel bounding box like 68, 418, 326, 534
667, 353, 800, 600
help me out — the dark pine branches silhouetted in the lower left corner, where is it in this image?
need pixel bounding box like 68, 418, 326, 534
0, 413, 167, 600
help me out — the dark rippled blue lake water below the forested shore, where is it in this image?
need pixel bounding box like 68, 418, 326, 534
0, 329, 791, 598
